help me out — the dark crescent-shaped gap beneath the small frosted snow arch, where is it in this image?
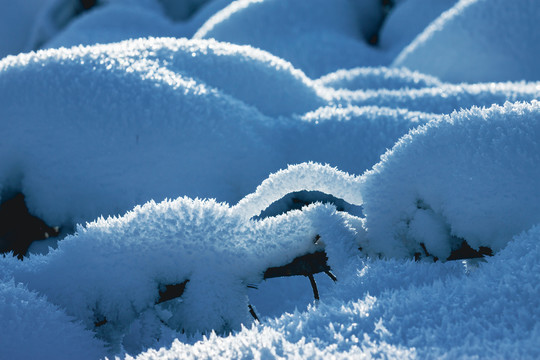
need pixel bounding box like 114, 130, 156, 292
254, 190, 362, 219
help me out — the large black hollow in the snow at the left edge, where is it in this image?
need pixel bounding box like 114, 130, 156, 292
0, 192, 60, 260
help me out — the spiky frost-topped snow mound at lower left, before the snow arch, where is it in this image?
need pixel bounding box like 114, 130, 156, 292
5, 198, 355, 352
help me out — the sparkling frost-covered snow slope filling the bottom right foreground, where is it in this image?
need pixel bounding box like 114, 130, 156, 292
126, 219, 540, 360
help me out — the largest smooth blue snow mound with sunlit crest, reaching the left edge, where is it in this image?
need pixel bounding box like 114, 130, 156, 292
0, 39, 433, 226
